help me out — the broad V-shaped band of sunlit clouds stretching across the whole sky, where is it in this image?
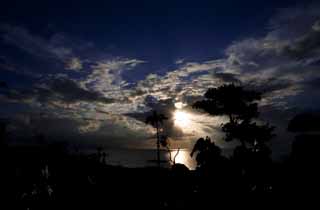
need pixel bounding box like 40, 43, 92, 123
0, 2, 320, 153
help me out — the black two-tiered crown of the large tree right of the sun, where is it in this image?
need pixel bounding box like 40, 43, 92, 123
193, 84, 274, 150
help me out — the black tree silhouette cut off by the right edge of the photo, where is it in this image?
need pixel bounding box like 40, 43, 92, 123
286, 113, 320, 193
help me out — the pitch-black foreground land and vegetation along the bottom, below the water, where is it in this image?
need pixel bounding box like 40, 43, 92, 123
1, 143, 319, 209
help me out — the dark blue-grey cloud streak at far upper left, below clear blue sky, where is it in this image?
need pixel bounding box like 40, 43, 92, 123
0, 24, 97, 76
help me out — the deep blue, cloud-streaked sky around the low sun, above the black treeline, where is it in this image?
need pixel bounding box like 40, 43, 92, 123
0, 0, 320, 159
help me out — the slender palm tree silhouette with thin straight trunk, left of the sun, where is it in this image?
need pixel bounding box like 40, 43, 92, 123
146, 110, 168, 167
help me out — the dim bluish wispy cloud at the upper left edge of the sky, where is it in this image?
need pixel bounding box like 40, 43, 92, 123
0, 24, 92, 73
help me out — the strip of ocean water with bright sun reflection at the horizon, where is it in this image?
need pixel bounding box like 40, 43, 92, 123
94, 149, 196, 170
